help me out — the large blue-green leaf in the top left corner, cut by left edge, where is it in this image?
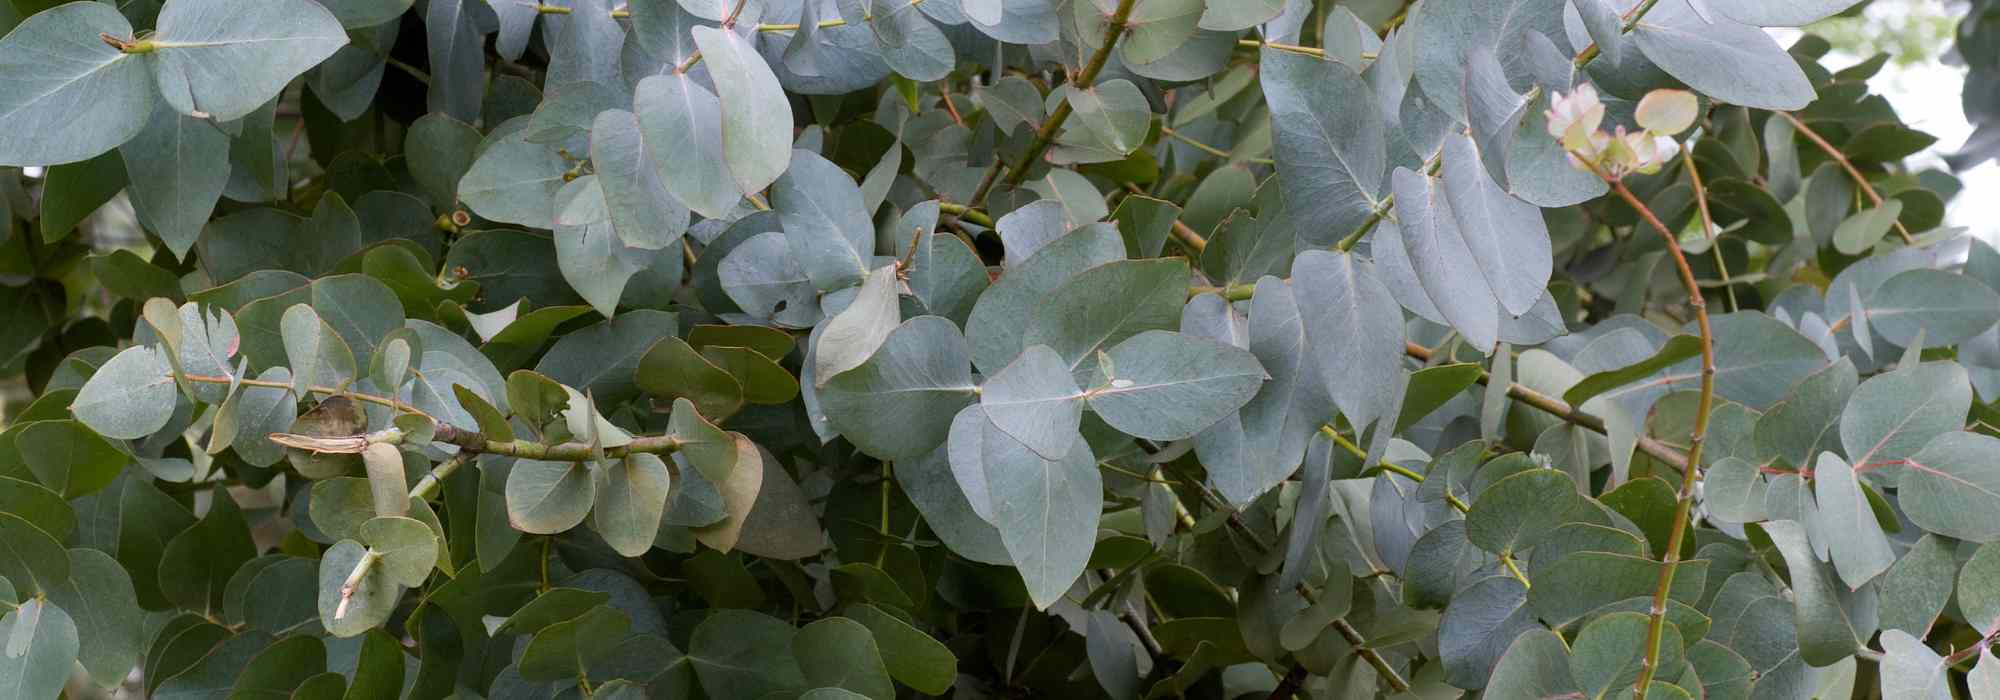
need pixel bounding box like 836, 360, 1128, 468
0, 2, 156, 166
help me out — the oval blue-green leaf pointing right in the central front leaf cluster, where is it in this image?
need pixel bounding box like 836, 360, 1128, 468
1084, 330, 1266, 440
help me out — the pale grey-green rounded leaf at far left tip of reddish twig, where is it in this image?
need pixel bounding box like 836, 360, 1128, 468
70, 346, 178, 440
